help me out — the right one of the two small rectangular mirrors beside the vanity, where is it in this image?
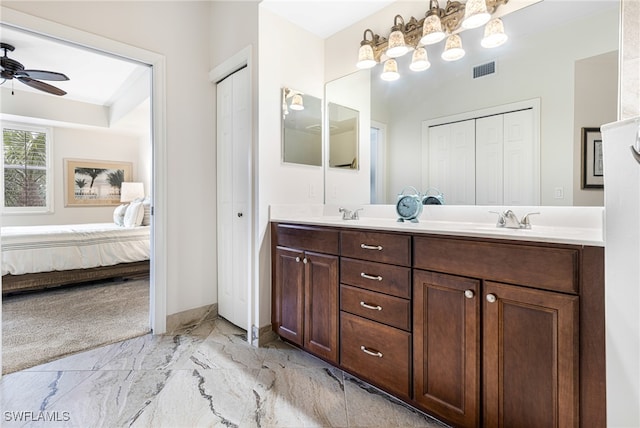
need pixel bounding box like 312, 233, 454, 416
327, 102, 360, 169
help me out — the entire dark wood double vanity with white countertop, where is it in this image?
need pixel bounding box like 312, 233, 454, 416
271, 206, 606, 427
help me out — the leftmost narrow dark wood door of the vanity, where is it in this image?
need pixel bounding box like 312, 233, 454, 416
272, 247, 304, 346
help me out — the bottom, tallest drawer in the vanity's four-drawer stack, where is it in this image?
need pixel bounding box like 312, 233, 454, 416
340, 312, 411, 399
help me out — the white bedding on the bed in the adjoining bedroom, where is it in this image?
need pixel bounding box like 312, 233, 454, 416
1, 223, 150, 275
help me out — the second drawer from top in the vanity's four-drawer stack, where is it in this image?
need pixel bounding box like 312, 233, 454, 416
340, 257, 411, 299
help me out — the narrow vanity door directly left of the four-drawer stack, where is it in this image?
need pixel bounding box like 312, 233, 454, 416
304, 252, 339, 364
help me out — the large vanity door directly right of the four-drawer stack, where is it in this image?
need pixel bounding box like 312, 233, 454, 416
413, 270, 480, 427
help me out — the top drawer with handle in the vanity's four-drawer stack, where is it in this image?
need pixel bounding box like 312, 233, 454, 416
340, 231, 411, 266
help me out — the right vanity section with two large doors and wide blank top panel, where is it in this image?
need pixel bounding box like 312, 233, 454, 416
413, 236, 606, 427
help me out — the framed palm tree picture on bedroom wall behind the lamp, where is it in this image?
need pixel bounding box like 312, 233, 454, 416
64, 159, 133, 207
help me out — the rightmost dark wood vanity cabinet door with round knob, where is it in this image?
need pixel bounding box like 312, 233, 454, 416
483, 281, 588, 428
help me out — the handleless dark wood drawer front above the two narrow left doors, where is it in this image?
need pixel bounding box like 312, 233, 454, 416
274, 224, 340, 255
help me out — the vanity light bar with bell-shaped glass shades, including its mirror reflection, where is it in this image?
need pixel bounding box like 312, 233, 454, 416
356, 0, 509, 80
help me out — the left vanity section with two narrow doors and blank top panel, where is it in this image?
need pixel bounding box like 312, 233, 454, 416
271, 225, 339, 364
